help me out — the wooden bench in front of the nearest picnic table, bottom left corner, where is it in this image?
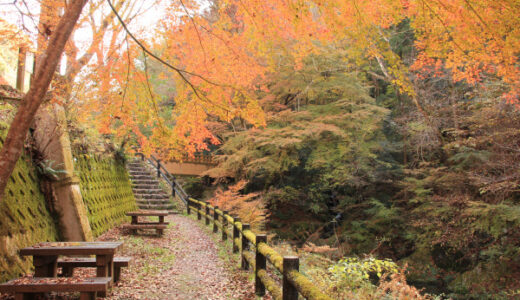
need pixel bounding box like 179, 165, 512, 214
0, 277, 112, 300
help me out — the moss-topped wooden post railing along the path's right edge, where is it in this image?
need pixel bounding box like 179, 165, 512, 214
186, 197, 332, 300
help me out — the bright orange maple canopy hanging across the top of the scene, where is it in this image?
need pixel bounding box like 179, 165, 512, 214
72, 0, 520, 156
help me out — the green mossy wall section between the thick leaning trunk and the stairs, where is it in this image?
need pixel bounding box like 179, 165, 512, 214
74, 155, 137, 236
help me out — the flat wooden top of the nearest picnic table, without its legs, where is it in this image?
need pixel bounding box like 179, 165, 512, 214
19, 242, 123, 256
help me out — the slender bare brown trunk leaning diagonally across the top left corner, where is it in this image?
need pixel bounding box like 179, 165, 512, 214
0, 0, 88, 201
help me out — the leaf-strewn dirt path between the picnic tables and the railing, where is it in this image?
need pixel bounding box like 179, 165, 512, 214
98, 215, 255, 300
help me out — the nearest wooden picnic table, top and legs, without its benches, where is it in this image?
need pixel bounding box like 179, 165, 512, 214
20, 242, 123, 281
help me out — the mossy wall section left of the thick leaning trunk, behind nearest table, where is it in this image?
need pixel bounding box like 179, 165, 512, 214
0, 124, 59, 282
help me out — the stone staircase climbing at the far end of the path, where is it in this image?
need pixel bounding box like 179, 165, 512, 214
127, 160, 173, 210
